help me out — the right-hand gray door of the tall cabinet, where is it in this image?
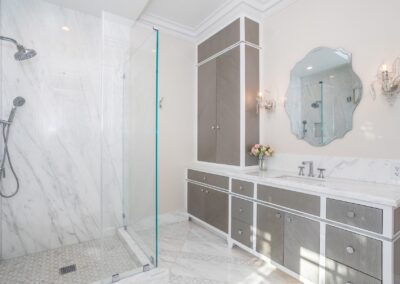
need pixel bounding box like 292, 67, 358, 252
216, 47, 240, 166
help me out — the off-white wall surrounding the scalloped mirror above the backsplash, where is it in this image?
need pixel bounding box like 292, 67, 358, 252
261, 0, 400, 159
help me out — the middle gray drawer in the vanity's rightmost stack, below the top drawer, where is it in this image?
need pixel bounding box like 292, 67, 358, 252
326, 225, 382, 280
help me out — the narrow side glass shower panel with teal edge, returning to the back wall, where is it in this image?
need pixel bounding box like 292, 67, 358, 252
124, 27, 158, 266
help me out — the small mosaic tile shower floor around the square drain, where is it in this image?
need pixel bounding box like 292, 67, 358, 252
0, 236, 140, 284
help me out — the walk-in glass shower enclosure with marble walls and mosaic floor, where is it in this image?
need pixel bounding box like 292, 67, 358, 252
0, 0, 159, 284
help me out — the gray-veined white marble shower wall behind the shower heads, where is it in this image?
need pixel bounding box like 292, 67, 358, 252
0, 0, 129, 258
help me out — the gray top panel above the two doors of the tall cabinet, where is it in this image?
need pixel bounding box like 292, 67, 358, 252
197, 19, 240, 62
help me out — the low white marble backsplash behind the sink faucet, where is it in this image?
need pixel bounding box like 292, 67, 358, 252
268, 154, 400, 185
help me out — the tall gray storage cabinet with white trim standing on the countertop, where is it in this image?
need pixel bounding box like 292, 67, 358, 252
197, 17, 259, 166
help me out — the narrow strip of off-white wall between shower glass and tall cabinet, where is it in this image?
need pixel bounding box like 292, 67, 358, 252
159, 30, 196, 213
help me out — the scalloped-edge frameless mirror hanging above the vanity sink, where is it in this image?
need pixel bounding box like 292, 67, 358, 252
285, 47, 362, 146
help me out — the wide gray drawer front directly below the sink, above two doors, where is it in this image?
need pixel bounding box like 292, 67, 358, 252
257, 184, 320, 216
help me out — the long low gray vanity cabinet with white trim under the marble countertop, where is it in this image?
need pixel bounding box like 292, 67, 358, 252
188, 168, 400, 284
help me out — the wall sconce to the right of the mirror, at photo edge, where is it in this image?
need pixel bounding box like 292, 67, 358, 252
371, 58, 400, 103
